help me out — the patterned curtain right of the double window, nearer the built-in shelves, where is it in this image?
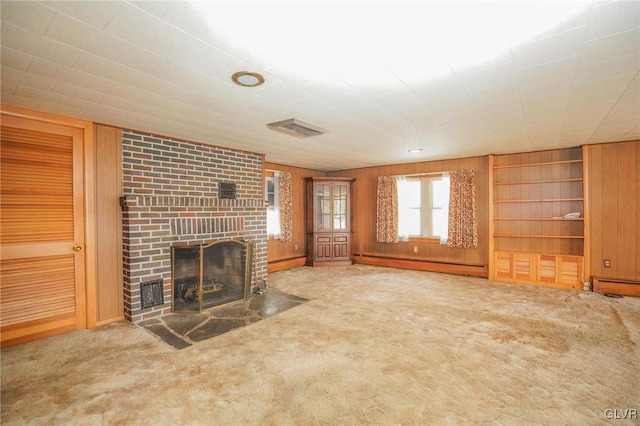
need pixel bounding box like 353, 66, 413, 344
447, 170, 478, 248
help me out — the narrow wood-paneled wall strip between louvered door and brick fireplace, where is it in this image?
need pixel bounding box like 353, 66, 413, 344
94, 125, 124, 325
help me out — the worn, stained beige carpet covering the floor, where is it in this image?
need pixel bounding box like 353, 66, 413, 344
2, 265, 640, 425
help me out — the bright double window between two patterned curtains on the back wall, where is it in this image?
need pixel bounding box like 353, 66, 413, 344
398, 174, 449, 241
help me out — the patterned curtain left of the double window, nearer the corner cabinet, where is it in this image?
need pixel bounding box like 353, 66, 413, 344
376, 176, 398, 243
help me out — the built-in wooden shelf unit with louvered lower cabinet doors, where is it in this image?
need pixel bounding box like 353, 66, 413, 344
489, 147, 588, 289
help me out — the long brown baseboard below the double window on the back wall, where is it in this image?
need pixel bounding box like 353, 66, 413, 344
353, 254, 489, 278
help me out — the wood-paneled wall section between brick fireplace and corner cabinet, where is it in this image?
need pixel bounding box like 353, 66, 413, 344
264, 162, 326, 270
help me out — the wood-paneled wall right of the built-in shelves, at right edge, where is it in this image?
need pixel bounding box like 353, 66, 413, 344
586, 141, 640, 280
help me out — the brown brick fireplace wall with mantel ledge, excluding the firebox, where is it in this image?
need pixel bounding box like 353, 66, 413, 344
121, 131, 267, 322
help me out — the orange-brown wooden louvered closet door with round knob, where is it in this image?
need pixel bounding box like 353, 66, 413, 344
0, 115, 86, 346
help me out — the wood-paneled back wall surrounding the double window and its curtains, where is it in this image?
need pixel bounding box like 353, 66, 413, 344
329, 157, 489, 266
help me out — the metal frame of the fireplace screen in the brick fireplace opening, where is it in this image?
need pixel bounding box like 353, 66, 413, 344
171, 238, 253, 313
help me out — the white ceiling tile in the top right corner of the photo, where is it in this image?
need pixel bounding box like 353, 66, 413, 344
586, 1, 640, 40
